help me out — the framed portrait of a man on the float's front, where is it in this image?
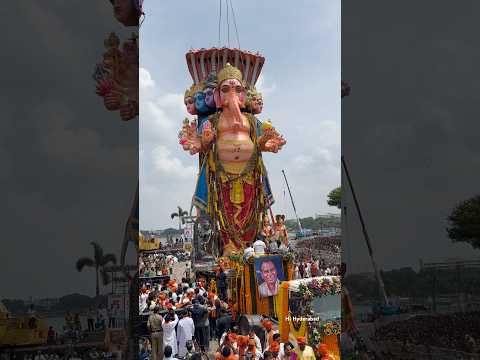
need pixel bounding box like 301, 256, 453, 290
255, 256, 285, 297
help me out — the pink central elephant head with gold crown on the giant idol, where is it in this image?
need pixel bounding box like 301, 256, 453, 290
214, 63, 246, 125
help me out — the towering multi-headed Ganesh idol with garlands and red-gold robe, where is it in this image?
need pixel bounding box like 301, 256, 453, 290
179, 48, 286, 256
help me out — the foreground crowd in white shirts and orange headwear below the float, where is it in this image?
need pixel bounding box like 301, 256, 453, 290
139, 306, 331, 360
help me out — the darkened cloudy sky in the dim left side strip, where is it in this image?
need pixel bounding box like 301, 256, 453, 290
0, 0, 138, 299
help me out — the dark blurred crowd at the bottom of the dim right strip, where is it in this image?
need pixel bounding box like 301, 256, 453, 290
372, 311, 480, 353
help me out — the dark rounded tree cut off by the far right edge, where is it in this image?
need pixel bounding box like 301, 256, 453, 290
447, 195, 480, 249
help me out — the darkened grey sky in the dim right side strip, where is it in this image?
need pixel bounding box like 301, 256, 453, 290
342, 0, 480, 271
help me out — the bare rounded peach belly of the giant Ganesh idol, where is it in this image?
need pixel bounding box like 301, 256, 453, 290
217, 133, 254, 172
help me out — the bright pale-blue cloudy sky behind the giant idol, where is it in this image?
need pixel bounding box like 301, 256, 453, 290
139, 0, 341, 229
